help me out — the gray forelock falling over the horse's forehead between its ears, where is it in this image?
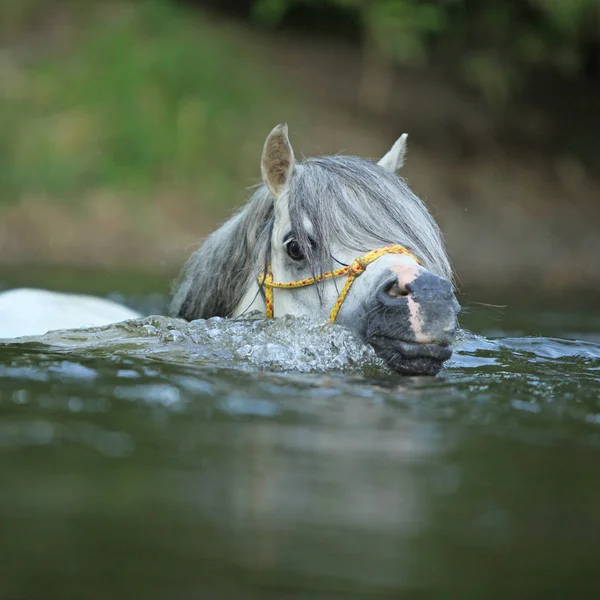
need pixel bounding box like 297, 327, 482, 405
287, 156, 452, 279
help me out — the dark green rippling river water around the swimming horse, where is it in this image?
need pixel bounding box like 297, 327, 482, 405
0, 278, 600, 600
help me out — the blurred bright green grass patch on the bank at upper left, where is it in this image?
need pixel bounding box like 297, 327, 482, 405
0, 0, 292, 206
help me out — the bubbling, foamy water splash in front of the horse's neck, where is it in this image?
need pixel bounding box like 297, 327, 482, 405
13, 316, 386, 374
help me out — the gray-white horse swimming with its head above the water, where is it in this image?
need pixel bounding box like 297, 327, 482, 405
0, 123, 460, 374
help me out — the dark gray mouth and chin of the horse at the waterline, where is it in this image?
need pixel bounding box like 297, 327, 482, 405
368, 335, 452, 375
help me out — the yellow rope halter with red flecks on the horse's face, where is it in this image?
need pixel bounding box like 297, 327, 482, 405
258, 245, 421, 323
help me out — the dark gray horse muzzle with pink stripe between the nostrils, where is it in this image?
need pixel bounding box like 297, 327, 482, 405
364, 265, 460, 375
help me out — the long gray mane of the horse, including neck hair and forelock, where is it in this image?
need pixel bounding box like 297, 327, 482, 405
171, 156, 452, 320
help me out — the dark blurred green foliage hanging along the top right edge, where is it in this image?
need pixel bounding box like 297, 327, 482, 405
253, 0, 600, 106
